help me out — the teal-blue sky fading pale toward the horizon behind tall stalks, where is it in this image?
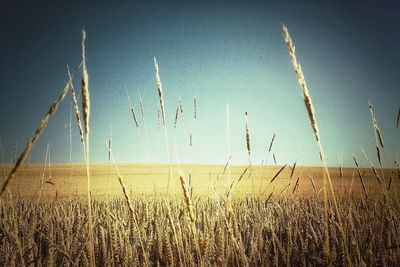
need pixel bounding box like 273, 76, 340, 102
0, 0, 400, 166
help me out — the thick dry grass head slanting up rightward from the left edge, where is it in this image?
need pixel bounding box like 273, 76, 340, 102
0, 75, 72, 197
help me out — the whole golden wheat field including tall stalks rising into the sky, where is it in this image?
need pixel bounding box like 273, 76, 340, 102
0, 26, 400, 266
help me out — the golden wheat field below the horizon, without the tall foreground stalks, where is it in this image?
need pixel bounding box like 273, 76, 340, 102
0, 164, 400, 266
